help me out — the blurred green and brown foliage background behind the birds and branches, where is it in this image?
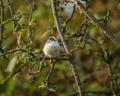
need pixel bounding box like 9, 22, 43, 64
0, 0, 120, 96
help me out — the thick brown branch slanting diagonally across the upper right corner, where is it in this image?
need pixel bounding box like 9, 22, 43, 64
70, 0, 120, 46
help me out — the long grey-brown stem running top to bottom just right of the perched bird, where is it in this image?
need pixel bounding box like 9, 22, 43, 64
51, 0, 83, 96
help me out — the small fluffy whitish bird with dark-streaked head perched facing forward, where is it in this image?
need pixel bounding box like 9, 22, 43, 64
43, 36, 60, 58
